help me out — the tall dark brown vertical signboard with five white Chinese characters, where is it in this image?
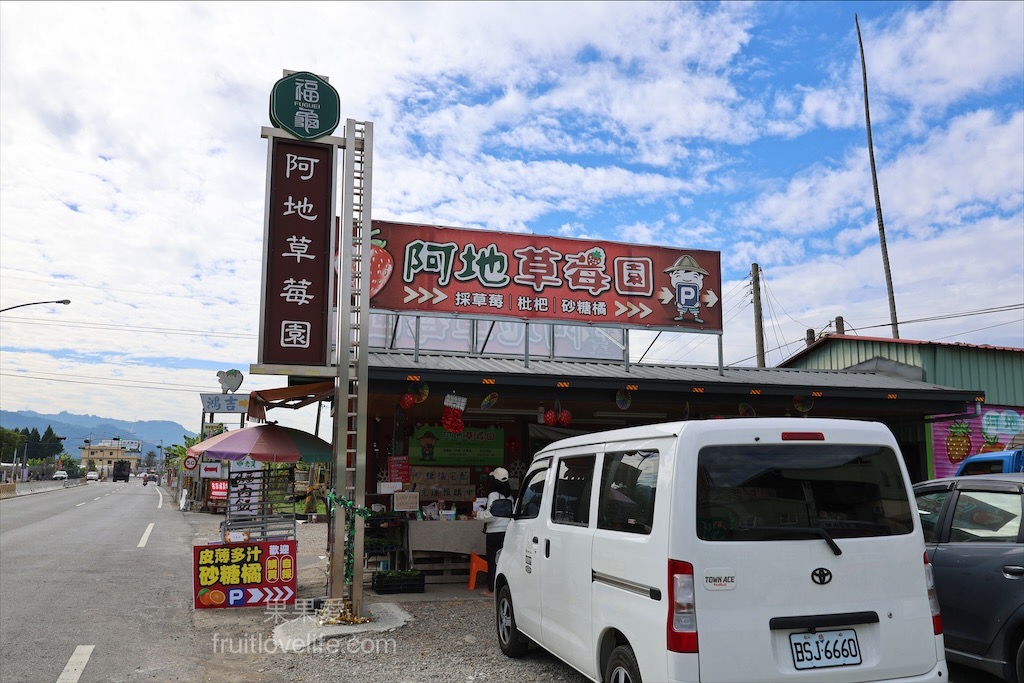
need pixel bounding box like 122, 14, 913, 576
259, 137, 336, 367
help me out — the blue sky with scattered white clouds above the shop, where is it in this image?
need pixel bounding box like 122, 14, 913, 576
0, 1, 1024, 446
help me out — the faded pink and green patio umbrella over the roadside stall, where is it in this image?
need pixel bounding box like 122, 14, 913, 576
188, 424, 334, 463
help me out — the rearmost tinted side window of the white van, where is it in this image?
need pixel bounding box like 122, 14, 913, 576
597, 451, 658, 533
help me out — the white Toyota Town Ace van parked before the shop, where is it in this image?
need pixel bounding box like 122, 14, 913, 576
492, 418, 949, 683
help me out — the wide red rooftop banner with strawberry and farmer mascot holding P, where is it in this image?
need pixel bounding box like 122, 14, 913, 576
370, 221, 722, 331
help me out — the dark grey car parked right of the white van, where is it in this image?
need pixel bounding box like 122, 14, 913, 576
913, 472, 1024, 683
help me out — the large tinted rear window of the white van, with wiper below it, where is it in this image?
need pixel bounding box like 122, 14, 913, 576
696, 442, 913, 541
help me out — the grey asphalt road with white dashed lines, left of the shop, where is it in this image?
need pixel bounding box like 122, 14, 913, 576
0, 479, 272, 683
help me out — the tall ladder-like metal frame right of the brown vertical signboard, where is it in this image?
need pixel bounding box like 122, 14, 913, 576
329, 119, 374, 614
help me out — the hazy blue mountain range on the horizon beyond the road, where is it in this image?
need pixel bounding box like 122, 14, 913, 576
0, 411, 196, 458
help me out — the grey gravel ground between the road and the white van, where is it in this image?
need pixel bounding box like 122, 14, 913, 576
185, 513, 587, 683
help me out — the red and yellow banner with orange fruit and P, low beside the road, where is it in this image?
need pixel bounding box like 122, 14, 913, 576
193, 539, 298, 609
